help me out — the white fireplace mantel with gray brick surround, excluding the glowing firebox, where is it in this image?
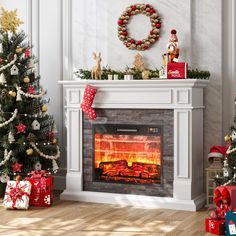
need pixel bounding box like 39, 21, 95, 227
61, 79, 209, 211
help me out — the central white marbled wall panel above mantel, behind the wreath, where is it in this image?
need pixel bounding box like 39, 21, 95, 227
72, 0, 191, 70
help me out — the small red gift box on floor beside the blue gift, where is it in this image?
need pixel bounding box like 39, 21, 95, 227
205, 218, 225, 235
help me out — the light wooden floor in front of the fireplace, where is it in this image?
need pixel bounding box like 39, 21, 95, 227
0, 200, 214, 236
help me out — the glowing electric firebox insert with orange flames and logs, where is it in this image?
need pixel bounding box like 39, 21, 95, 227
93, 124, 162, 184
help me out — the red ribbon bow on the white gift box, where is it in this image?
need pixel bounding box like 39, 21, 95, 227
5, 181, 30, 208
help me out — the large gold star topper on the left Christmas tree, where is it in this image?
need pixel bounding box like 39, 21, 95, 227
0, 8, 24, 33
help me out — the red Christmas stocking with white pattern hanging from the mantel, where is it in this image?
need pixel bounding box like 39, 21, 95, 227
80, 85, 97, 120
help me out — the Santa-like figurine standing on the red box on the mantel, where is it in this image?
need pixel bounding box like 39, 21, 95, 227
167, 29, 179, 62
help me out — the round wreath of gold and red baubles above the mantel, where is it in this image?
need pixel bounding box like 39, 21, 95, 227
117, 4, 161, 51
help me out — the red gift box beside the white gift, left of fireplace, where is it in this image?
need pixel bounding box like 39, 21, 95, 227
27, 171, 53, 207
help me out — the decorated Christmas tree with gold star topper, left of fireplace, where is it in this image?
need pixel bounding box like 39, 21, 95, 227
0, 9, 60, 182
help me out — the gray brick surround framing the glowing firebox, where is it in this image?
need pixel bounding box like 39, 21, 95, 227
83, 109, 174, 197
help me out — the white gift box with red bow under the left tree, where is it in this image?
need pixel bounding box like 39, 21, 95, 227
3, 181, 31, 209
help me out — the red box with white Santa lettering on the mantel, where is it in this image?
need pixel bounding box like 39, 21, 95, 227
166, 62, 188, 79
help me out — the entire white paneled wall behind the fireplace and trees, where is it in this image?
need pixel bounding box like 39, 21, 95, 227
0, 0, 236, 188
